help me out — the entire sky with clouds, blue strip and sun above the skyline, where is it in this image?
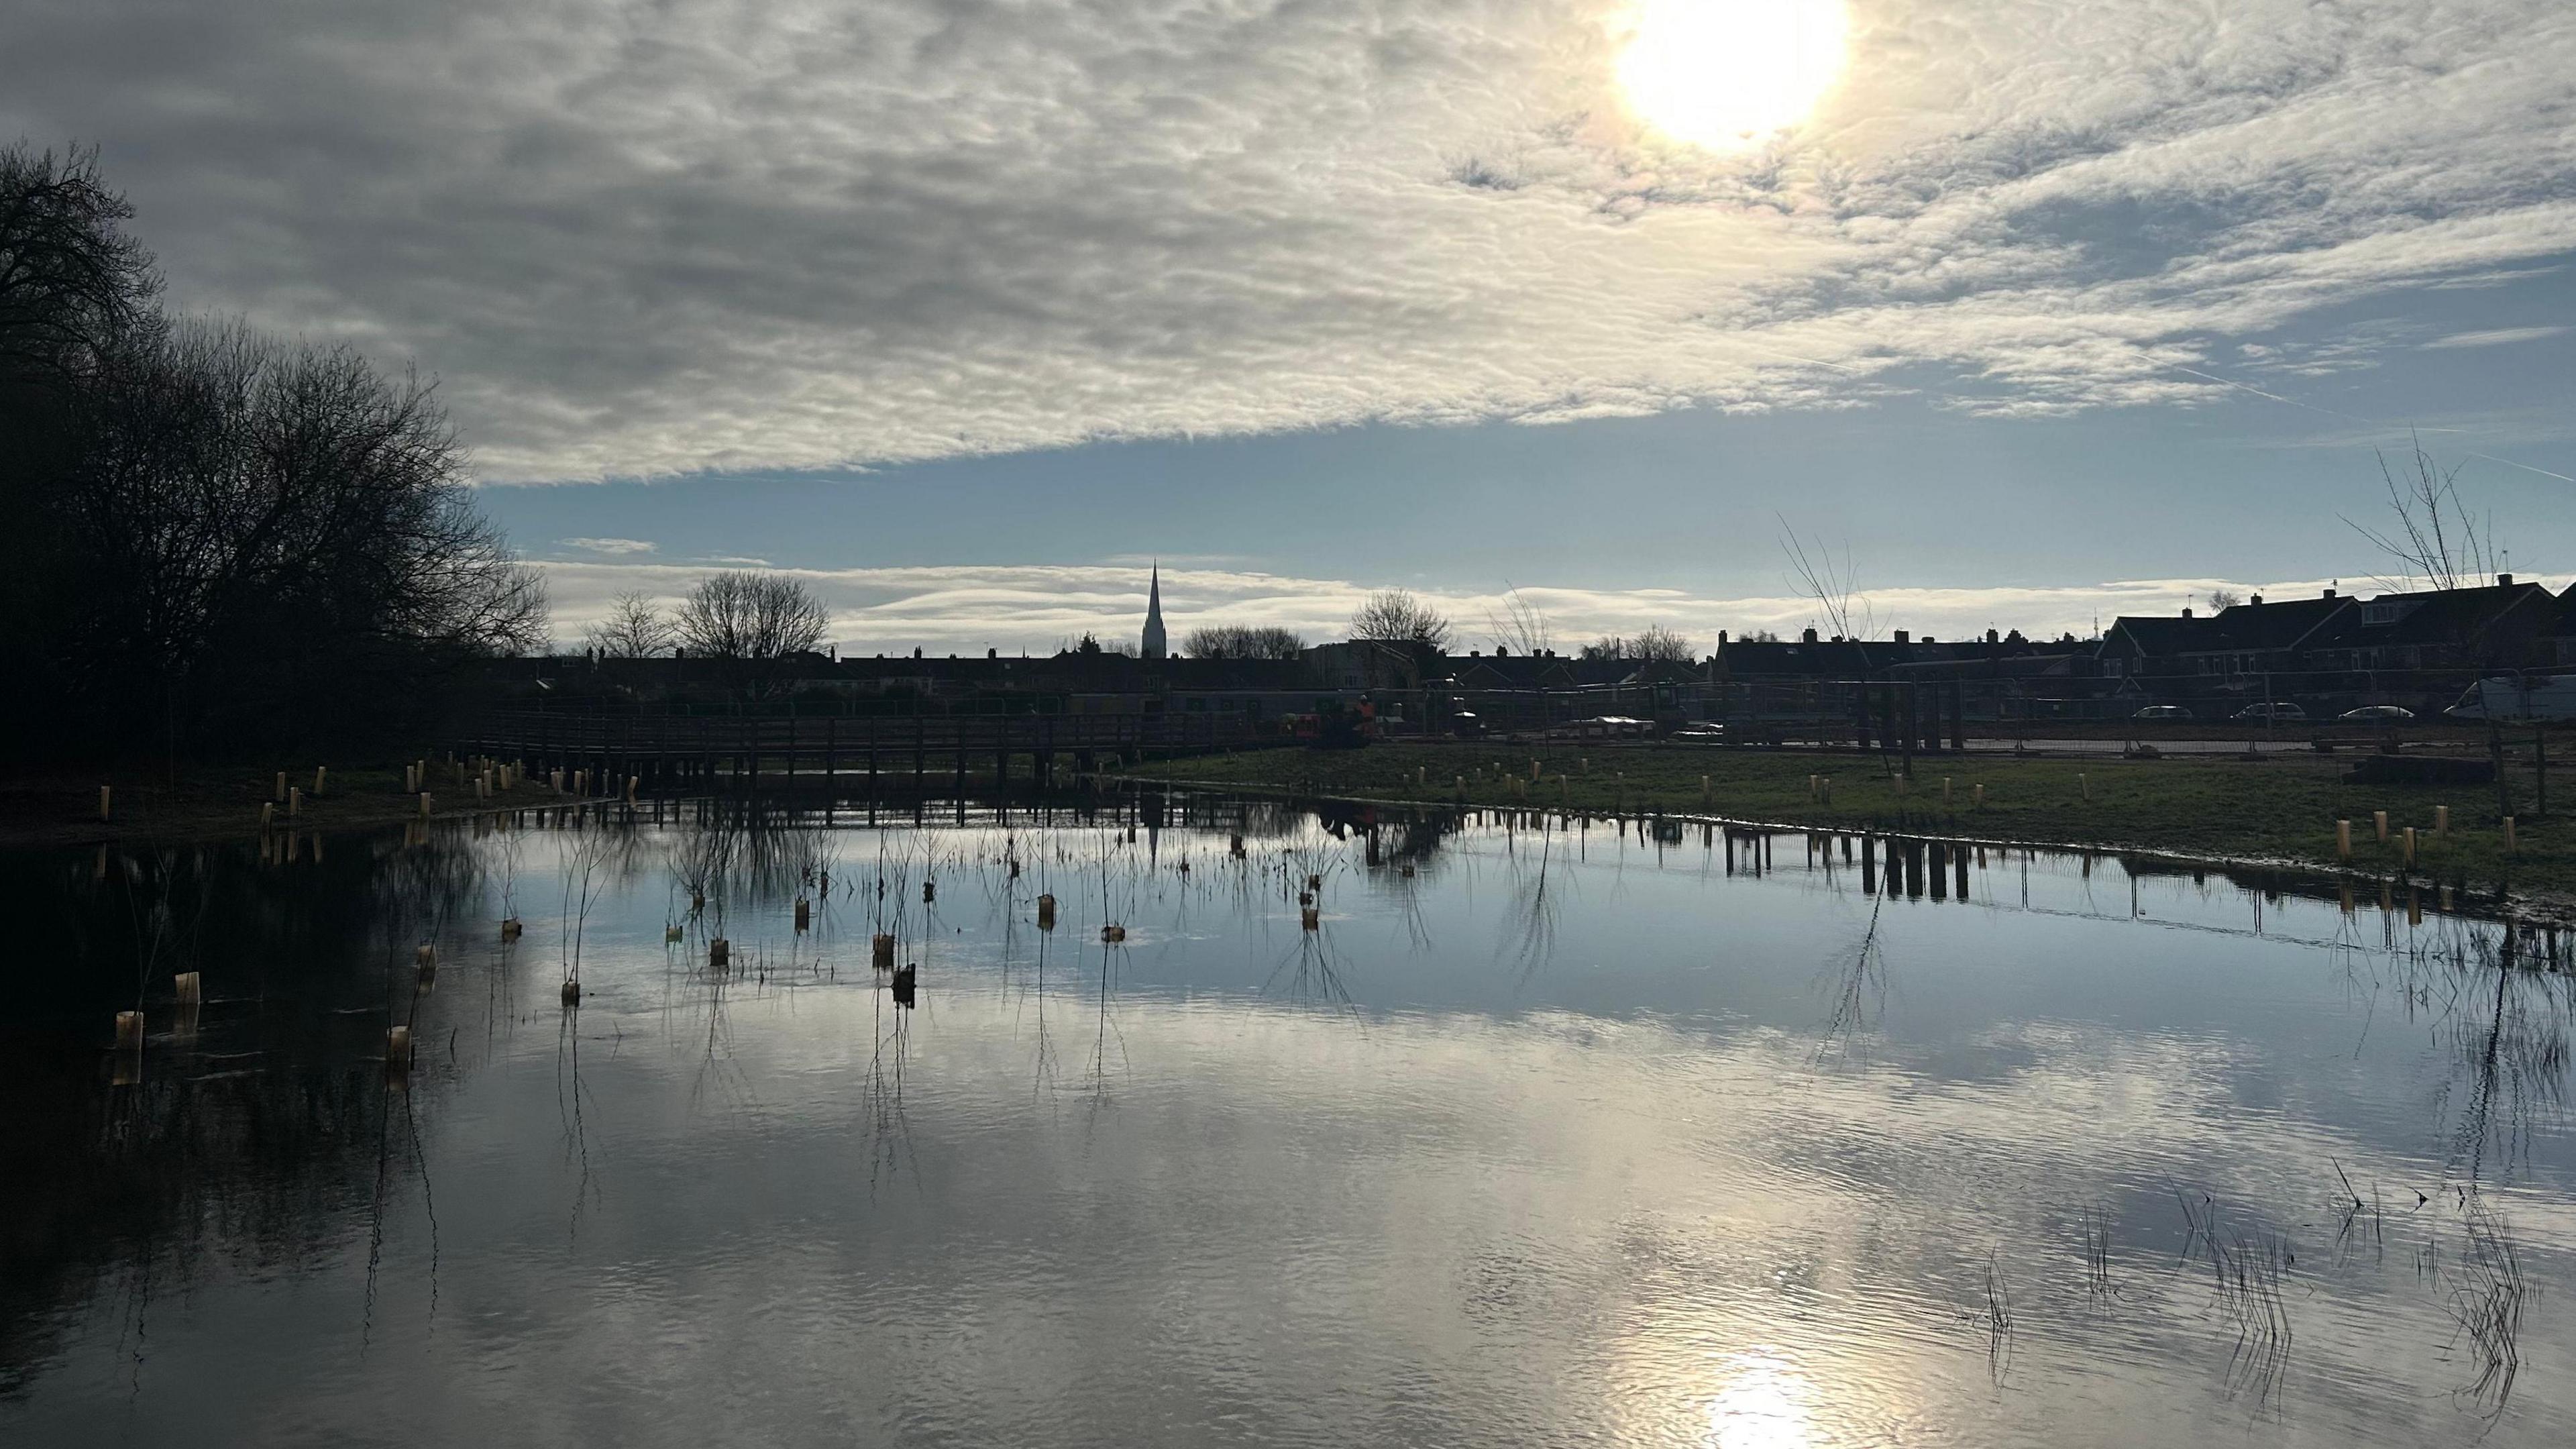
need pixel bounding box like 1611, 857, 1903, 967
0, 0, 2576, 642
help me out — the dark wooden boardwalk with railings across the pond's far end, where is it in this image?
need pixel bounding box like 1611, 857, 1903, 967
451, 709, 1285, 794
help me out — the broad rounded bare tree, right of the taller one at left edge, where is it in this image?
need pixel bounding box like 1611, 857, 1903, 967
52, 322, 546, 730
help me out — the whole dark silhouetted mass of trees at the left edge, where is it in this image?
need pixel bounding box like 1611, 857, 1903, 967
0, 142, 549, 755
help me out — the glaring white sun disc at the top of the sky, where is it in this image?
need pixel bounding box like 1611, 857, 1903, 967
1618, 0, 1849, 150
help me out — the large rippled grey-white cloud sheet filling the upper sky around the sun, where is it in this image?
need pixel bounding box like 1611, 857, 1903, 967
0, 0, 2576, 480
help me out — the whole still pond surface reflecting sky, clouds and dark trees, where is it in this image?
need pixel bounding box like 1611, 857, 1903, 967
0, 802, 2576, 1446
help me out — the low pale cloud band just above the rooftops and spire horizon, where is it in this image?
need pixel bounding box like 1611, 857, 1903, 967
539, 562, 2563, 655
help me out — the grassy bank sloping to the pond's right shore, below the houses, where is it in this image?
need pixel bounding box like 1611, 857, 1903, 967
1131, 745, 2576, 900
